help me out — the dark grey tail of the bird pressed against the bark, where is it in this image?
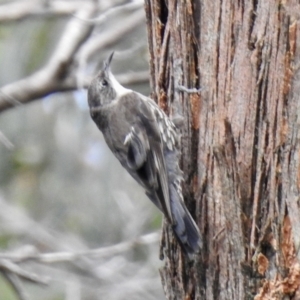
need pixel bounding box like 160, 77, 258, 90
169, 184, 202, 257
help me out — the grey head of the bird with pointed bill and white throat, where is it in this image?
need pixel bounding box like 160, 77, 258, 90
88, 52, 124, 110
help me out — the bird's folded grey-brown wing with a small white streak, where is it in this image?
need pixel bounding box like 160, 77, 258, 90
121, 94, 173, 224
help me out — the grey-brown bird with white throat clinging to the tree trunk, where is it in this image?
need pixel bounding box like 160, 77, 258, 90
88, 52, 202, 258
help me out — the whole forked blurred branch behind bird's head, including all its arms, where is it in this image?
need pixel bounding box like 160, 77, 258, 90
0, 1, 148, 112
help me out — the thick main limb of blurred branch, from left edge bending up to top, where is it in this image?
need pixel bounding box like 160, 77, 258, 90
0, 5, 95, 111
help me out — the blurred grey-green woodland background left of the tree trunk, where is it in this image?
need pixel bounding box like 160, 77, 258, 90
0, 0, 164, 300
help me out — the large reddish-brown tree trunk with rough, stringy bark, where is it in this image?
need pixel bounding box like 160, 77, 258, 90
145, 0, 300, 300
